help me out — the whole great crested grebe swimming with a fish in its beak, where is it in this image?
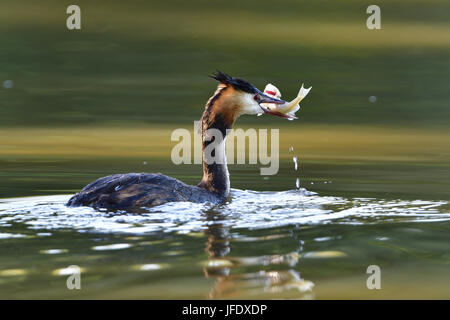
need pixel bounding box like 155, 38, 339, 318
67, 71, 285, 209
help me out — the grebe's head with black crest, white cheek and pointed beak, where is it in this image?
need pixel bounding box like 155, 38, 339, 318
211, 71, 285, 121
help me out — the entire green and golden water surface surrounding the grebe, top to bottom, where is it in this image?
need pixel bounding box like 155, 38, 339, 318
0, 0, 450, 299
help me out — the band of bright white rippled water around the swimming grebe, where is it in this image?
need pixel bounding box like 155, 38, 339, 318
0, 192, 450, 238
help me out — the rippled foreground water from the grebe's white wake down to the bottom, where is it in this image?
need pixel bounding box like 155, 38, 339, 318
0, 188, 450, 299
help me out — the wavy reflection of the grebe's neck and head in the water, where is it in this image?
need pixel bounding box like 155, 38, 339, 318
203, 212, 314, 299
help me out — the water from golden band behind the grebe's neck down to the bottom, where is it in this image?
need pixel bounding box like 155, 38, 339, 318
0, 123, 450, 299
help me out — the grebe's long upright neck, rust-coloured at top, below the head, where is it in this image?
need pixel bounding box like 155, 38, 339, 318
198, 84, 239, 198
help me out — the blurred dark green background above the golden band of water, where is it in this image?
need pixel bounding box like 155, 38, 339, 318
0, 0, 450, 127
